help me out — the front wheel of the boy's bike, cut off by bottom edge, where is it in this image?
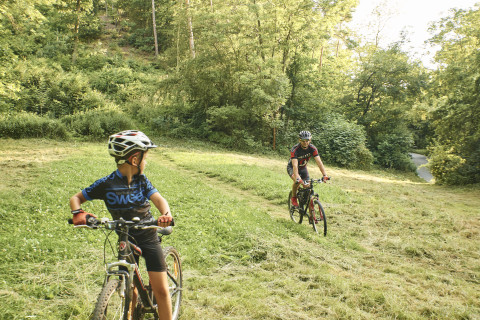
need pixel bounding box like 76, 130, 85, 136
91, 279, 128, 320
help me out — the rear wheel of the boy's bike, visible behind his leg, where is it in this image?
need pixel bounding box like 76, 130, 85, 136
163, 247, 183, 320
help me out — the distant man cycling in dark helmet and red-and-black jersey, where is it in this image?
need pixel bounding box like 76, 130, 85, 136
287, 131, 329, 207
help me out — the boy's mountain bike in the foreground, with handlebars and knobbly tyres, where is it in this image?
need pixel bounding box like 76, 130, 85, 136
69, 217, 182, 320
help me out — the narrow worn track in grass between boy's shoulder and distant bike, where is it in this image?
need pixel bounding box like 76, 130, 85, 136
155, 158, 290, 219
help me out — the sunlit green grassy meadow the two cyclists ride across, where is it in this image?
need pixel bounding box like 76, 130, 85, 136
0, 139, 480, 320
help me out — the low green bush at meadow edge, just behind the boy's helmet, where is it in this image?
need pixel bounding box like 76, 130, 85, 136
62, 106, 135, 139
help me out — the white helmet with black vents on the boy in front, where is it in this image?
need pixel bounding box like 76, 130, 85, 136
108, 130, 157, 158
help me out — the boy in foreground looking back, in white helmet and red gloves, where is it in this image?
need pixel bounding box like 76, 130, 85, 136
70, 130, 172, 320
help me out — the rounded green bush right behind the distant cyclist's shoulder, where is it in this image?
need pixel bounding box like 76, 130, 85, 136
312, 116, 373, 169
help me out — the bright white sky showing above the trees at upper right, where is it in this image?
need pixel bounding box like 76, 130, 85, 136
350, 0, 480, 68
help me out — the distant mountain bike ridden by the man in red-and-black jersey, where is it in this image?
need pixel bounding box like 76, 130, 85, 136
288, 178, 330, 236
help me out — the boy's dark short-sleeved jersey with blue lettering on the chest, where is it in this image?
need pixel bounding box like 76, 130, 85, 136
82, 170, 158, 242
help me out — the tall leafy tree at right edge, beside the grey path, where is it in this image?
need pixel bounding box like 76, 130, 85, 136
431, 6, 480, 184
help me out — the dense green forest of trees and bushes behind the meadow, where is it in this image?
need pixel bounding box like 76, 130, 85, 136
0, 0, 480, 184
